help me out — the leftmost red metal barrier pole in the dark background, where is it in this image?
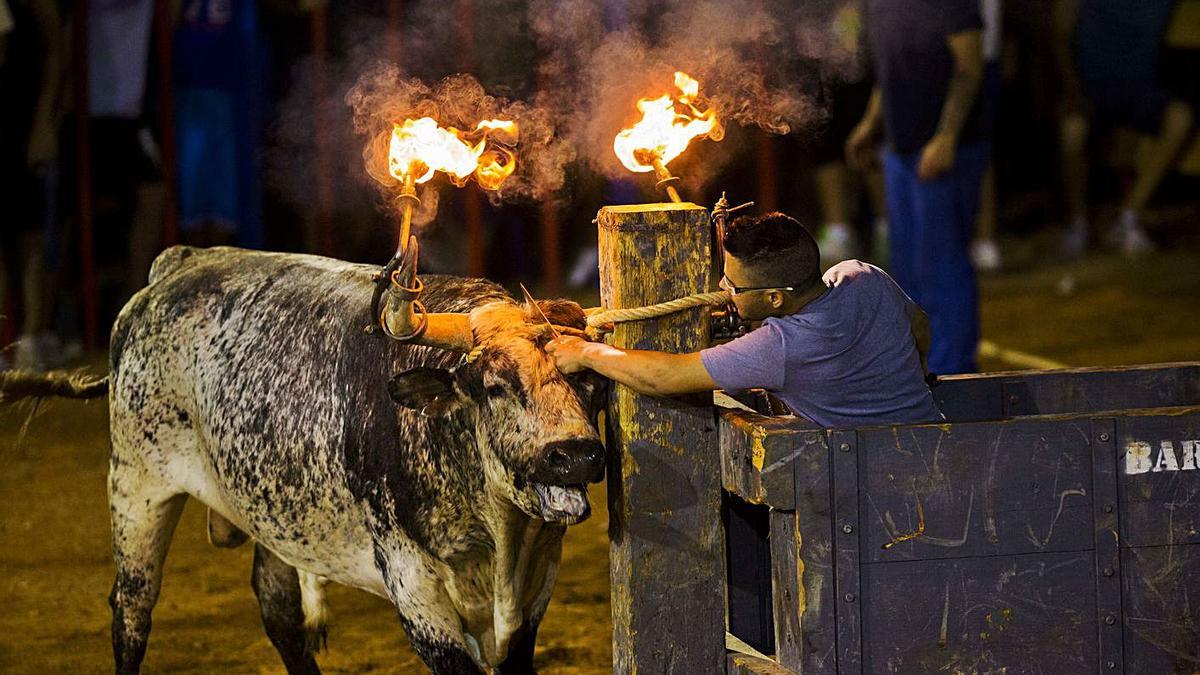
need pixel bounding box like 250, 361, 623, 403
71, 0, 98, 350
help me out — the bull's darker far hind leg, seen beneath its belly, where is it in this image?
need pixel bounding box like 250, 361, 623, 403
251, 543, 323, 675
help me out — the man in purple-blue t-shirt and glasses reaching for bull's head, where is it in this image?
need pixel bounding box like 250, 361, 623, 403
546, 214, 942, 426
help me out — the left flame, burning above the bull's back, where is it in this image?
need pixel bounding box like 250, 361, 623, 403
388, 118, 517, 190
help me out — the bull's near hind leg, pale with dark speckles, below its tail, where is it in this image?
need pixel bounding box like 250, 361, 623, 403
108, 473, 187, 674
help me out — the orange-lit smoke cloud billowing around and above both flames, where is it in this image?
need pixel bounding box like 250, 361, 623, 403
266, 0, 863, 225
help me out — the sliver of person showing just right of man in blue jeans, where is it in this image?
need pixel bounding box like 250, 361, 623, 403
971, 0, 1004, 271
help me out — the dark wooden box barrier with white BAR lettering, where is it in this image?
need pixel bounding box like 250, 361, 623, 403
700, 363, 1200, 674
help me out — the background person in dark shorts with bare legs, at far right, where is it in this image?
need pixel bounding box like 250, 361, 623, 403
1055, 0, 1194, 256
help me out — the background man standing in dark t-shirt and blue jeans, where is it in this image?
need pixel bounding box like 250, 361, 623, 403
846, 0, 989, 374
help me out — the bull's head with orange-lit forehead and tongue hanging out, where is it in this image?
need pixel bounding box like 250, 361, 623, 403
383, 295, 605, 525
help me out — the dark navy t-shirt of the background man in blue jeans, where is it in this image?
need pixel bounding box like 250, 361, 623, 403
866, 0, 984, 155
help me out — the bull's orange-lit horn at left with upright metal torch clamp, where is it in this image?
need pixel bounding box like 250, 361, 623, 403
379, 237, 474, 353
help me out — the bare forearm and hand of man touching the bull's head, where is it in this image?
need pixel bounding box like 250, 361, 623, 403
546, 336, 716, 396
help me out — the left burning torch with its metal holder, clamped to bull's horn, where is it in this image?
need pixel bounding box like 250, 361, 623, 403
371, 118, 517, 340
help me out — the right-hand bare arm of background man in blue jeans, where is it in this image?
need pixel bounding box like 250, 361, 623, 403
917, 30, 983, 180
